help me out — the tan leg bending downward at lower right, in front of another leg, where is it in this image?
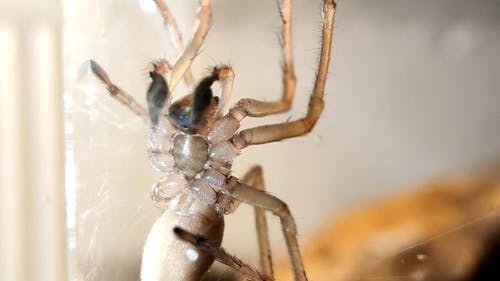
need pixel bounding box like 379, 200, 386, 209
225, 177, 307, 281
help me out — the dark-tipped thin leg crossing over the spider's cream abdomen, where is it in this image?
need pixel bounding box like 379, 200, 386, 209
174, 227, 273, 281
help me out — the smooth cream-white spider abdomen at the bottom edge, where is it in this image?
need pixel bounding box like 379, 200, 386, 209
141, 189, 224, 281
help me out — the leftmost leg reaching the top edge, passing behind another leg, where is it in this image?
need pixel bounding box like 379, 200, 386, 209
154, 0, 194, 87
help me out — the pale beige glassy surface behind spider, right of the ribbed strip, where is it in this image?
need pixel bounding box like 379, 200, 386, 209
64, 0, 500, 281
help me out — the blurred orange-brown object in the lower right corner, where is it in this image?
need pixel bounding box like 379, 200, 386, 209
276, 166, 500, 281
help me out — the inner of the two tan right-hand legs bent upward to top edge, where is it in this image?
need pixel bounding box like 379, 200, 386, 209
233, 0, 296, 117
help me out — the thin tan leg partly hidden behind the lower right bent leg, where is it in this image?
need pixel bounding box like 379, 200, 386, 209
243, 166, 274, 278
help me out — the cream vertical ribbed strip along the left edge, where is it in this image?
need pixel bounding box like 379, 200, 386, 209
0, 0, 68, 281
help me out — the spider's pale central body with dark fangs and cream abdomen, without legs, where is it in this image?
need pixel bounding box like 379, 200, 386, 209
141, 65, 244, 281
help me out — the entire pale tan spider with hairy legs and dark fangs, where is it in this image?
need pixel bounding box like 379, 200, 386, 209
90, 0, 335, 281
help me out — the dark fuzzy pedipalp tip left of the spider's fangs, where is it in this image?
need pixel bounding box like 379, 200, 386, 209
146, 71, 168, 125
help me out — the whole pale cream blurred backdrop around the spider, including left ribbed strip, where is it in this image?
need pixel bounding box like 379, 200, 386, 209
0, 0, 500, 280
